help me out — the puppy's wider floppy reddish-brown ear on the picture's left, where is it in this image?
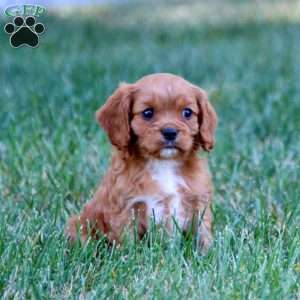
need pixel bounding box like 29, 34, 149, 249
96, 83, 136, 150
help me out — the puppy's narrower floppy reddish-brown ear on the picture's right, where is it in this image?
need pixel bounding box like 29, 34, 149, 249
194, 86, 218, 151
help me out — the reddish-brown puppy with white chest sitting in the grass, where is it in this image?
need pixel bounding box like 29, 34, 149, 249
67, 73, 217, 248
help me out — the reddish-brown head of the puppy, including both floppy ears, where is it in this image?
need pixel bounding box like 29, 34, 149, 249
96, 74, 217, 159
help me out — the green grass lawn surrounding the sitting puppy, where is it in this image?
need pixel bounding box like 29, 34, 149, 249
0, 1, 300, 299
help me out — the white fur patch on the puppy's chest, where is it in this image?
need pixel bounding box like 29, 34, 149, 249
147, 159, 186, 225
